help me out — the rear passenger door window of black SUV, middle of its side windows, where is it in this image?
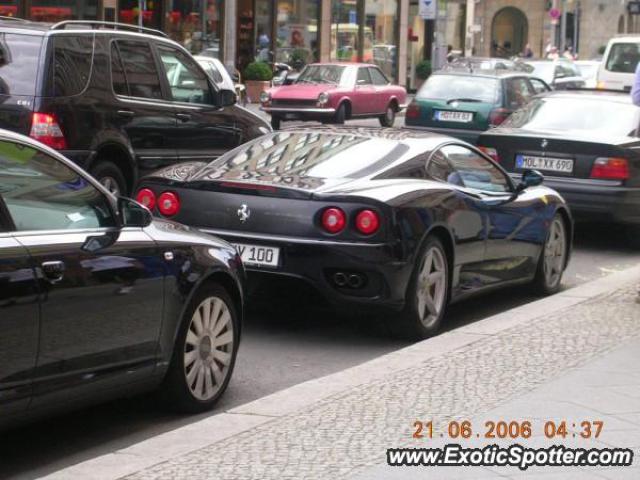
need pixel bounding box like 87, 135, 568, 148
114, 40, 162, 99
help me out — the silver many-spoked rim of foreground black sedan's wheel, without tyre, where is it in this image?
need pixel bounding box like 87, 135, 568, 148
184, 296, 234, 401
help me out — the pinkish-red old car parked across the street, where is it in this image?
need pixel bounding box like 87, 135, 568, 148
260, 63, 407, 130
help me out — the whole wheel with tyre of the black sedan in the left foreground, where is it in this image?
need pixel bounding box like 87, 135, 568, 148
159, 284, 240, 413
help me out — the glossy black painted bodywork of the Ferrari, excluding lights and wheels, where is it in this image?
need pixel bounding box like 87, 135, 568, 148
138, 129, 572, 310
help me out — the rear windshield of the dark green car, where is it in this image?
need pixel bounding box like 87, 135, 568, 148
417, 75, 499, 103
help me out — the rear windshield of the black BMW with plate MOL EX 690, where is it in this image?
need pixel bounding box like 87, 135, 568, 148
502, 97, 640, 136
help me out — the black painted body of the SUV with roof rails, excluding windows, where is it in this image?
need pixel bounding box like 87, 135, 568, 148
0, 20, 271, 190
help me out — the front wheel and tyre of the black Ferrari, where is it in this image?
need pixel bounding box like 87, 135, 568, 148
533, 213, 569, 295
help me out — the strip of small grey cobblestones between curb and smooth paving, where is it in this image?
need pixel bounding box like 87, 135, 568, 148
127, 285, 640, 480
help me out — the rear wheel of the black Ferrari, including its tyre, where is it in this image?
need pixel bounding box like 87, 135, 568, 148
396, 237, 450, 340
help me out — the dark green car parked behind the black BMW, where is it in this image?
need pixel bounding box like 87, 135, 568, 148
405, 70, 550, 143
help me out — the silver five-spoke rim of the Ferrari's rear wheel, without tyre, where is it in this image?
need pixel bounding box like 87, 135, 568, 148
416, 246, 447, 328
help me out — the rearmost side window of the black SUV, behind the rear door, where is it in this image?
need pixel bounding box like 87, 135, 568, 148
45, 34, 94, 97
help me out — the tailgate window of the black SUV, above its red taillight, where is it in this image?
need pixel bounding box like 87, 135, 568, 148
0, 33, 42, 95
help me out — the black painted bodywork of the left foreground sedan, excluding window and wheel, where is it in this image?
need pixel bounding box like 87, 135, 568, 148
0, 132, 245, 427
